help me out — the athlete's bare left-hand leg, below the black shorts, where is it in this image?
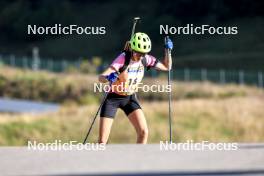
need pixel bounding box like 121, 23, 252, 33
98, 117, 114, 144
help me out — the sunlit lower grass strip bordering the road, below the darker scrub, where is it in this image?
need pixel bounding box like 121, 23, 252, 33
0, 97, 264, 145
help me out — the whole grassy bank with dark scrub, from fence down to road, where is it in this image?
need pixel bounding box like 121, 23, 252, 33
0, 68, 264, 145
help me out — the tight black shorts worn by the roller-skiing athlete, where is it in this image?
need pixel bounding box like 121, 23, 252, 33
100, 93, 141, 118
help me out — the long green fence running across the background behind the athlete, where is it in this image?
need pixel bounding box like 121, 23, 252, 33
0, 55, 264, 88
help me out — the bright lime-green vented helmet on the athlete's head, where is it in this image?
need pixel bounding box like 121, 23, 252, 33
130, 32, 151, 53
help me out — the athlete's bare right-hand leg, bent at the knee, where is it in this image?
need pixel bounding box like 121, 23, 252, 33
128, 109, 148, 144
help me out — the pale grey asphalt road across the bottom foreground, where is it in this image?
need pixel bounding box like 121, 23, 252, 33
0, 144, 264, 175
